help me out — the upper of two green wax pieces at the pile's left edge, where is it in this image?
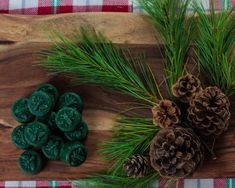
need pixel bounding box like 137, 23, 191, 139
11, 98, 34, 123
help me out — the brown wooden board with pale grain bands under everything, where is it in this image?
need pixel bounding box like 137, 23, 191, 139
0, 13, 235, 180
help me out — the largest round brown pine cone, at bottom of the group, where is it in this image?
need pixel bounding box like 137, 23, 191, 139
149, 127, 204, 178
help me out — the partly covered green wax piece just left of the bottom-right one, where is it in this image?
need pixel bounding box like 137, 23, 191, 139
42, 135, 64, 160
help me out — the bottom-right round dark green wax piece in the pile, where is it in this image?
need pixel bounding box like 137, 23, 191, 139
60, 141, 87, 166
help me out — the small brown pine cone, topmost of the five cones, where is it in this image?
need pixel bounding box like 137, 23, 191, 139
172, 74, 202, 103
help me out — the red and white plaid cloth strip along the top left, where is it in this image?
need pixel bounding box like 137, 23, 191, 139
0, 0, 133, 15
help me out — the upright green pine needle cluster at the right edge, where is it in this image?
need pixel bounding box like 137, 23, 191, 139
194, 4, 235, 95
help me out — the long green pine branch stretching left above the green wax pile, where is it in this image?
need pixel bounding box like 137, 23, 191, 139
39, 28, 161, 105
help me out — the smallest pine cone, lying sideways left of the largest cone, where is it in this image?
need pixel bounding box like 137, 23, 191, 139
124, 155, 150, 178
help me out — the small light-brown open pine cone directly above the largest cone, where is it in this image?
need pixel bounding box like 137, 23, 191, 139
152, 100, 181, 128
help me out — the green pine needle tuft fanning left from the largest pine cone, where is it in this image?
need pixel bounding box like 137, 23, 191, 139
100, 117, 159, 175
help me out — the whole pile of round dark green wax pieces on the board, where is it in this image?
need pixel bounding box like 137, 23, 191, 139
12, 83, 88, 175
